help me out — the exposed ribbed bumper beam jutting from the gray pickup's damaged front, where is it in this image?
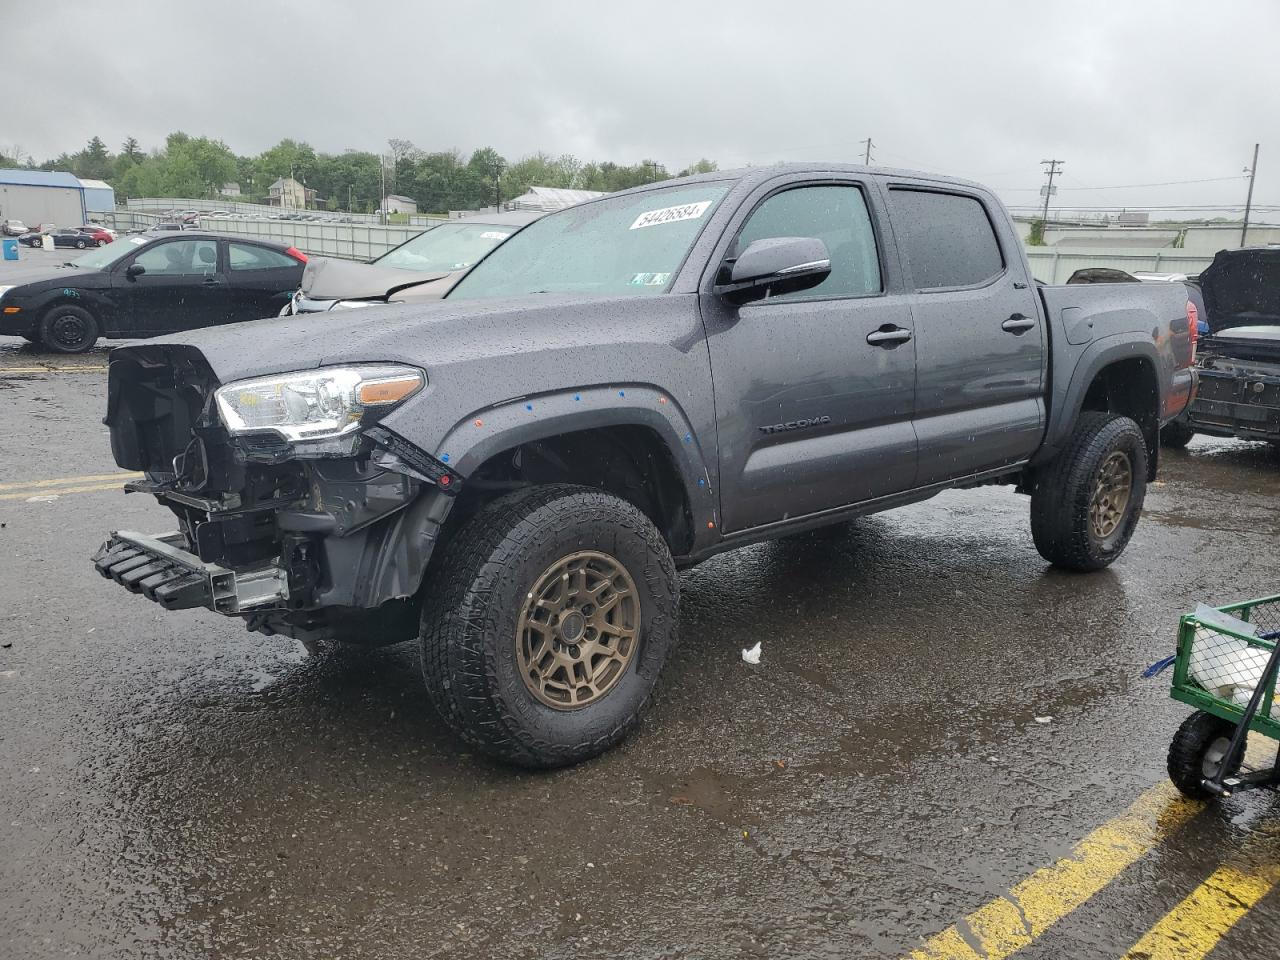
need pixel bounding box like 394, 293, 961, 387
92, 530, 289, 616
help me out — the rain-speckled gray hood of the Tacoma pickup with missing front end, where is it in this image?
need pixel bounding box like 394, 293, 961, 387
128, 294, 629, 384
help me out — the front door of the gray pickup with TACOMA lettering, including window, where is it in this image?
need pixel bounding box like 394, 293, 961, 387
703, 182, 916, 534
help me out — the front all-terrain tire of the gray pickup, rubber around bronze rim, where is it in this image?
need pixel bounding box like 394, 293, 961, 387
421, 484, 680, 768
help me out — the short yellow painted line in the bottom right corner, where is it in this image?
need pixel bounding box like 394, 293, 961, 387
1125, 841, 1280, 960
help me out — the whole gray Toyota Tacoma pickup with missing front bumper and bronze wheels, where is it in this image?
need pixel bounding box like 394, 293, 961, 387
93, 165, 1194, 767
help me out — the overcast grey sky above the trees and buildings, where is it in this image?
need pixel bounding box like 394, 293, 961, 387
0, 0, 1280, 216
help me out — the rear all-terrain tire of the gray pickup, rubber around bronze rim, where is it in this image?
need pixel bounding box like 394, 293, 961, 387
1032, 411, 1147, 571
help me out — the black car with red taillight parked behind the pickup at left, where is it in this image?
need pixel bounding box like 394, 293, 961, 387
0, 230, 307, 353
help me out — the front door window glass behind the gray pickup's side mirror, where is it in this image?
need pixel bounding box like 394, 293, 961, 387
736, 184, 881, 296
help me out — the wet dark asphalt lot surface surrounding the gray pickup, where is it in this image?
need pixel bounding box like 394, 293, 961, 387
0, 338, 1280, 960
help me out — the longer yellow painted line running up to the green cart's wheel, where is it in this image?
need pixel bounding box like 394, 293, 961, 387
911, 782, 1203, 960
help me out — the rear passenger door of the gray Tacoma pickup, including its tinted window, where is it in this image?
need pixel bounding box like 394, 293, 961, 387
888, 183, 1047, 486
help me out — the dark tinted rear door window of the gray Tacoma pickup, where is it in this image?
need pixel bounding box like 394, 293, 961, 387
890, 188, 1005, 291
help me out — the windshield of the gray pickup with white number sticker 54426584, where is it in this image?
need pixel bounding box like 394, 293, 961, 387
449, 180, 730, 300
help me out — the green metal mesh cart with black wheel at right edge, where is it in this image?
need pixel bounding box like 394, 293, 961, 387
1169, 595, 1280, 799
